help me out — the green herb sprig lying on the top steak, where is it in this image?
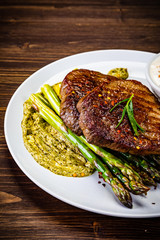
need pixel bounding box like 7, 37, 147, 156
110, 94, 145, 136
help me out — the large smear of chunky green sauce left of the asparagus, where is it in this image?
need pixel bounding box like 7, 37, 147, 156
21, 101, 94, 177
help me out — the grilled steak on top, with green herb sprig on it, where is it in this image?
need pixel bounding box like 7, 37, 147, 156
77, 80, 160, 155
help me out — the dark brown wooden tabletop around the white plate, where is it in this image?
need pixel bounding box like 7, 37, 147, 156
0, 0, 160, 239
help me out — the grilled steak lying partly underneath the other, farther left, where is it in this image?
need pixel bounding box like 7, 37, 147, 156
60, 69, 116, 135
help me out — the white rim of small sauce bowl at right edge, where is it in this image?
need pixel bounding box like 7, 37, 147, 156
146, 53, 160, 100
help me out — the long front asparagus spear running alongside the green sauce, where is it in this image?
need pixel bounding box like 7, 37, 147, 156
29, 94, 132, 208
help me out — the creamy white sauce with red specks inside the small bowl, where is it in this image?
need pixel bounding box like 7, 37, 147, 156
149, 56, 160, 87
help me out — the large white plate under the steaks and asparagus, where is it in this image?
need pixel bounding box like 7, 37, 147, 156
5, 50, 160, 218
